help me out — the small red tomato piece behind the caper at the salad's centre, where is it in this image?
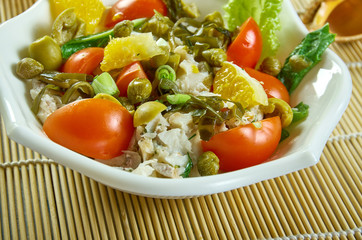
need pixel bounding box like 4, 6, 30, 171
116, 61, 148, 97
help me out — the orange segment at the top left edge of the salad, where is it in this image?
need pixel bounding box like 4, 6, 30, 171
50, 0, 106, 34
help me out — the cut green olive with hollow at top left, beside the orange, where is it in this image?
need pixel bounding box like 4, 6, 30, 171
52, 8, 85, 45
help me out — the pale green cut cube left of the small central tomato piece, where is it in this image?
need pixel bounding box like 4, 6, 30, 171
92, 72, 119, 97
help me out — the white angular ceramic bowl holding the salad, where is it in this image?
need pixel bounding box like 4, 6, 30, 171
0, 0, 352, 198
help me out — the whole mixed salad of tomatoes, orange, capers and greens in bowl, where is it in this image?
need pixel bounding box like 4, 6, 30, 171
16, 0, 334, 178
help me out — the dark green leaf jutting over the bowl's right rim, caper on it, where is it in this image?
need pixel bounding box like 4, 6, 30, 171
277, 24, 335, 93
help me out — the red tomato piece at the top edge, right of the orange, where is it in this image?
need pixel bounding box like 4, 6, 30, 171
105, 0, 167, 28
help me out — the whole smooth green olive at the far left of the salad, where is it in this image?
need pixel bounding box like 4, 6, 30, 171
29, 36, 62, 70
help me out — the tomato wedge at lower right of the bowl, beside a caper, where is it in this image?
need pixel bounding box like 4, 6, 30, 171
201, 117, 282, 172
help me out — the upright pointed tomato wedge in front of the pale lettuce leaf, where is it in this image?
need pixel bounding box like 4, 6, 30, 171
226, 17, 263, 68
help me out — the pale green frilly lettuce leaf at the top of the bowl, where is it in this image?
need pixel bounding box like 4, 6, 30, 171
224, 0, 283, 61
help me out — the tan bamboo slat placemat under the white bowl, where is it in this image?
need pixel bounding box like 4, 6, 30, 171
0, 0, 362, 239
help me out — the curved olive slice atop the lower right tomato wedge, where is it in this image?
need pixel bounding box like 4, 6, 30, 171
262, 98, 293, 128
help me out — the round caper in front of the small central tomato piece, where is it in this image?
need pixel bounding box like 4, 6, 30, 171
127, 78, 152, 104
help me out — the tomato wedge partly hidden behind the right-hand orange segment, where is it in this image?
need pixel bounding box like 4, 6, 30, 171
244, 67, 290, 103
